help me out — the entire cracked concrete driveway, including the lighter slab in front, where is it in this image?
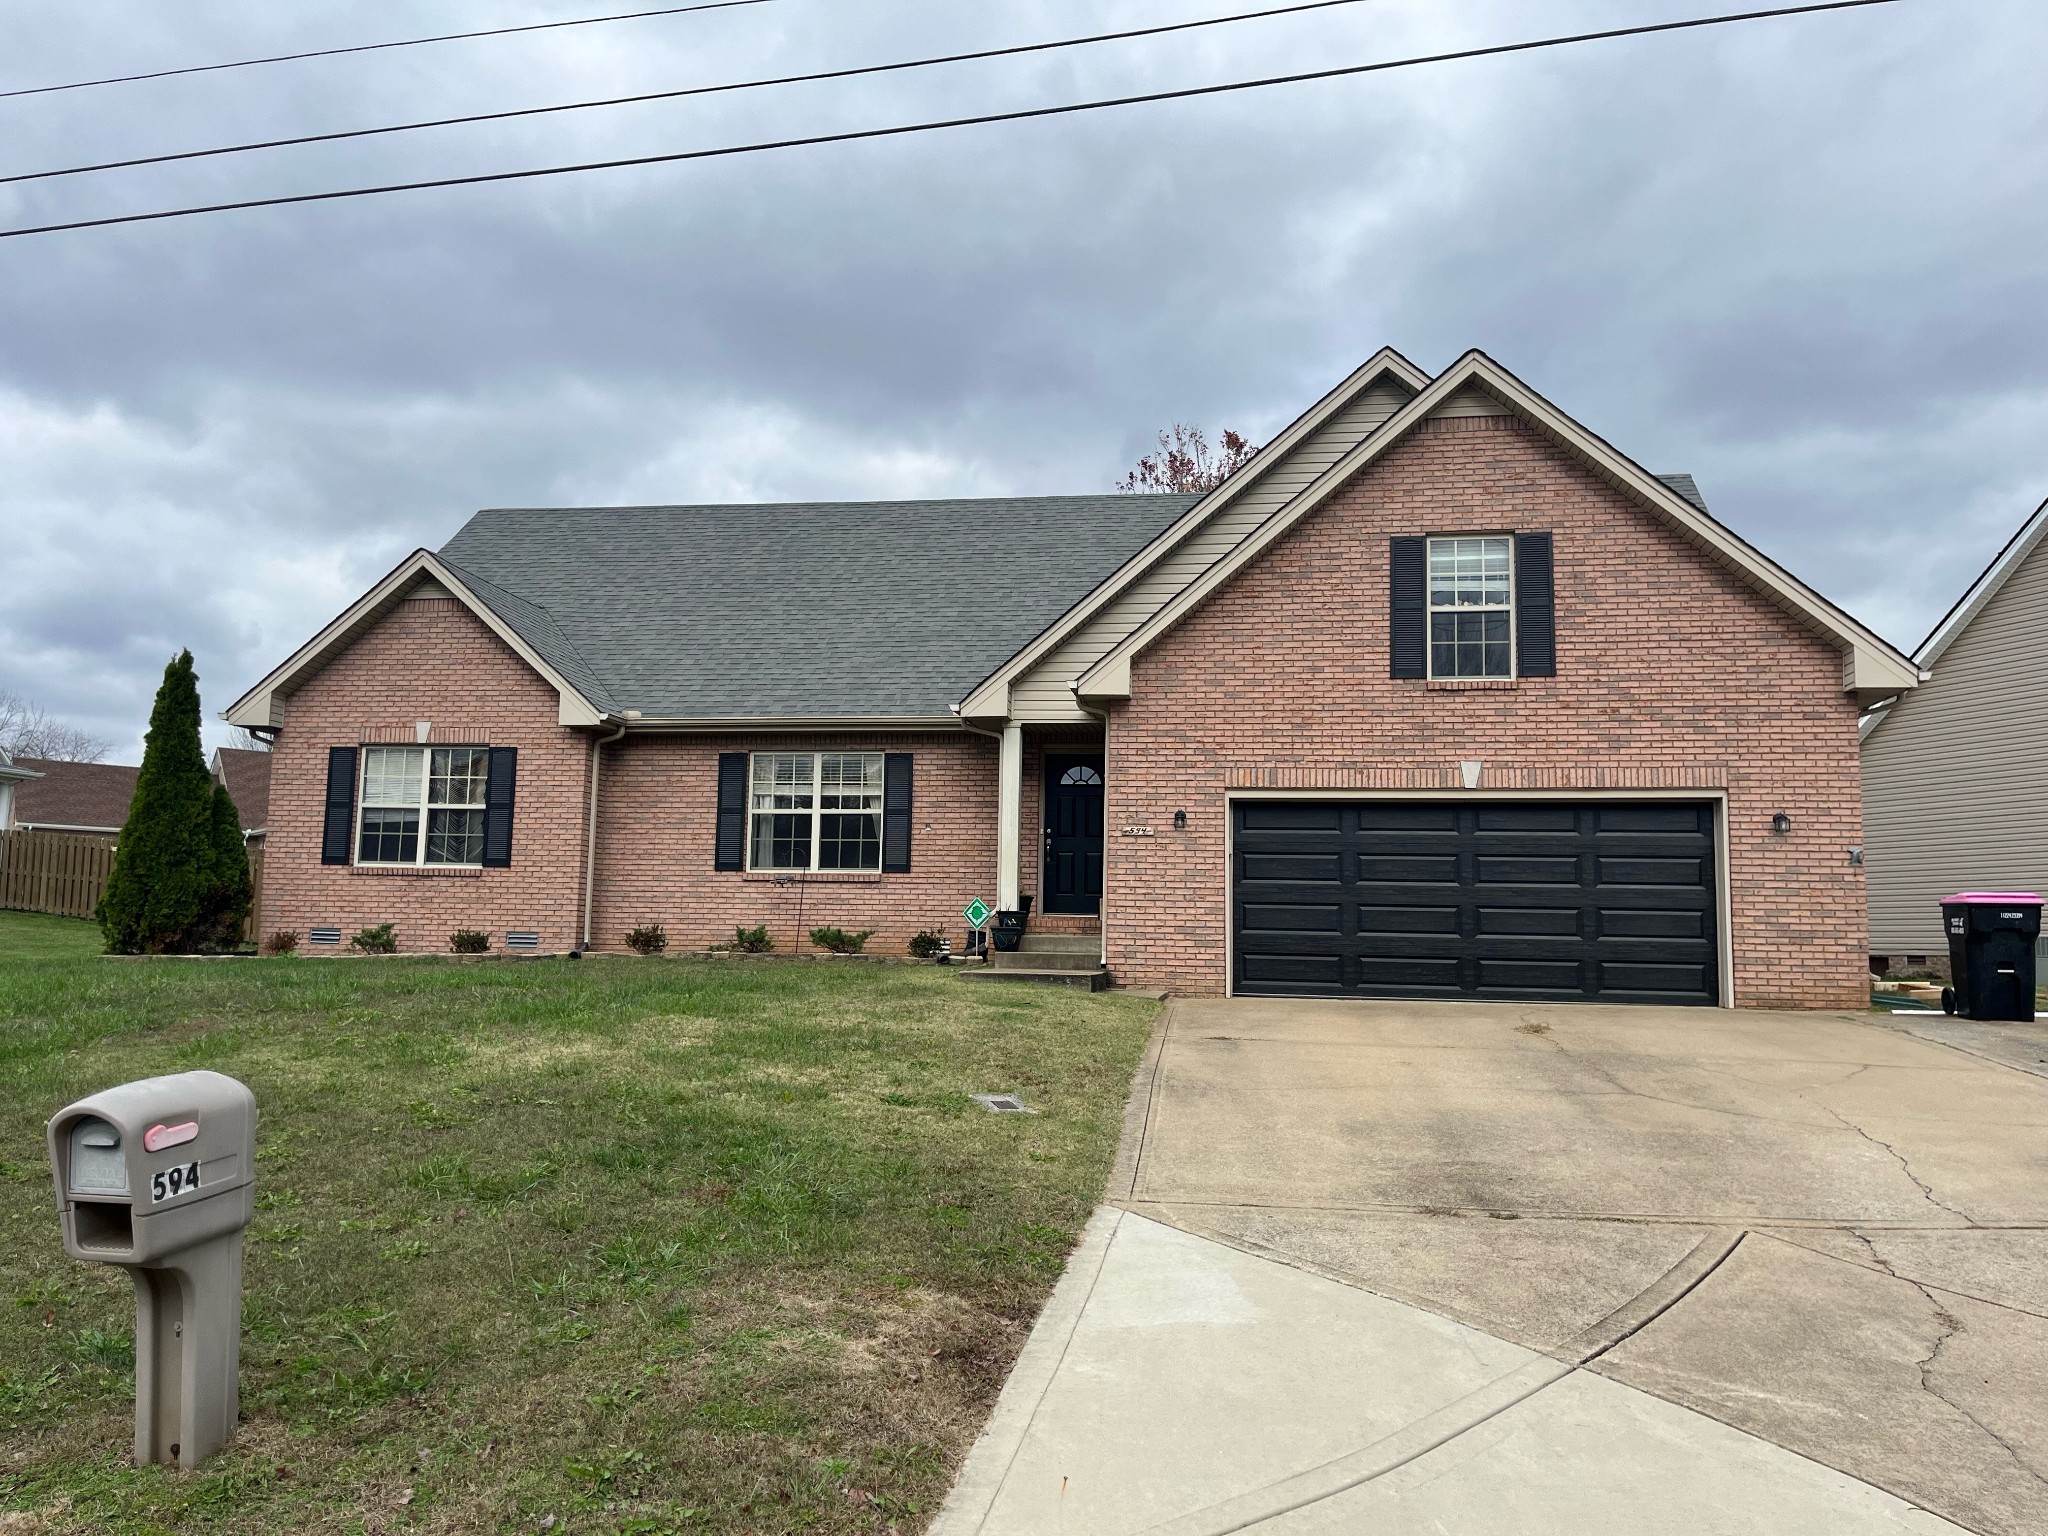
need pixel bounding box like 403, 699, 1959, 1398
934, 999, 2048, 1536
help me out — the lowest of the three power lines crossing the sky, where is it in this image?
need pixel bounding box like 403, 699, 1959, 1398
0, 0, 1898, 240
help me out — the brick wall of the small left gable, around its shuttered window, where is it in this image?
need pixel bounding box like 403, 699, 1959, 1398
262, 598, 590, 952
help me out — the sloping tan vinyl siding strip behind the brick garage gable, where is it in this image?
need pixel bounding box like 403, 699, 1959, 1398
1010, 379, 1417, 721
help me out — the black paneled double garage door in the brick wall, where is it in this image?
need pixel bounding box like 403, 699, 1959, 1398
1231, 801, 1720, 1004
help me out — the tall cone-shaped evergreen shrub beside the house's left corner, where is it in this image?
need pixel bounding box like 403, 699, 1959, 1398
98, 651, 250, 954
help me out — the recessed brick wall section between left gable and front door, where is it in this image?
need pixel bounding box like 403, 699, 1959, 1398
592, 731, 995, 954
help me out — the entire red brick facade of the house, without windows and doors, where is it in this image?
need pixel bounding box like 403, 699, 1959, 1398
262, 418, 1866, 1008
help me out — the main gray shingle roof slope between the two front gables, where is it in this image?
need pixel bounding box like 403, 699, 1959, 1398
440, 496, 1200, 719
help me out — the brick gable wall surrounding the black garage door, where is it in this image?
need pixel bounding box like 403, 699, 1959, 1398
1106, 416, 1868, 1008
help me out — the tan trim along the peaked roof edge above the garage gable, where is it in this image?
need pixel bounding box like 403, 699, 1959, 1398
1073, 350, 1919, 702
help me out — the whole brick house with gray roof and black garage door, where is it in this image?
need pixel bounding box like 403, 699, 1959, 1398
227, 350, 1919, 1008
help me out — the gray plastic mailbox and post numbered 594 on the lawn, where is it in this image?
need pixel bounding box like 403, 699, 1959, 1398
49, 1071, 256, 1466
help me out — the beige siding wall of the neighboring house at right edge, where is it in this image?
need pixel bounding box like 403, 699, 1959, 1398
1862, 541, 2048, 954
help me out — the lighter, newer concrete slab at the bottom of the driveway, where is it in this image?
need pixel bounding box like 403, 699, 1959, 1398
932, 1208, 1962, 1536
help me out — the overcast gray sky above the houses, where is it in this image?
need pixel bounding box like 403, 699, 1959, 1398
0, 0, 2048, 762
